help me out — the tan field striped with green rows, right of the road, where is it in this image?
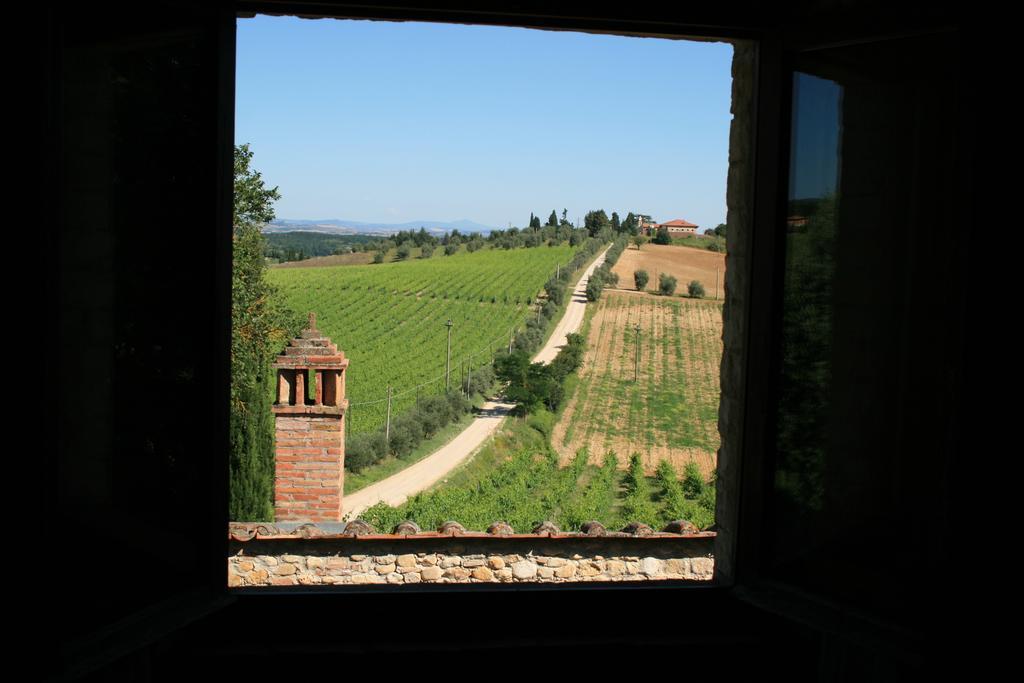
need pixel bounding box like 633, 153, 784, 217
552, 290, 722, 476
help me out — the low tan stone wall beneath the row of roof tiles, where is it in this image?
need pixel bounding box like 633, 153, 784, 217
227, 532, 715, 588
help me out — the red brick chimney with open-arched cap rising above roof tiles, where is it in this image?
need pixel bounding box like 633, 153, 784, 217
273, 313, 348, 521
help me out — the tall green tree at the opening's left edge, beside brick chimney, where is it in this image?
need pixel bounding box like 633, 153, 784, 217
228, 144, 301, 521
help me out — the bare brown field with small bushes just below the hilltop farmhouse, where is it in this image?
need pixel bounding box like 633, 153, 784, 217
612, 244, 725, 301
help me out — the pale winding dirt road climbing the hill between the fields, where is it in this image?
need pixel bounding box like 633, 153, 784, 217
341, 249, 608, 519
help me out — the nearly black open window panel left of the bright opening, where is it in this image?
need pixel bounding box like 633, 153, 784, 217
54, 7, 229, 647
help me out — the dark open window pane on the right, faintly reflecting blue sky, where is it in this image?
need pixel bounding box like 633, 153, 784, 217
766, 37, 963, 616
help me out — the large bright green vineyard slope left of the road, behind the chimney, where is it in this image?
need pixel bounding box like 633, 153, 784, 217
267, 246, 575, 434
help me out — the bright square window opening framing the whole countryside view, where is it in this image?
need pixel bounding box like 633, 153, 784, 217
231, 16, 732, 586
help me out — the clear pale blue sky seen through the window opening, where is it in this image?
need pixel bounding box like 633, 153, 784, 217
234, 16, 732, 227
